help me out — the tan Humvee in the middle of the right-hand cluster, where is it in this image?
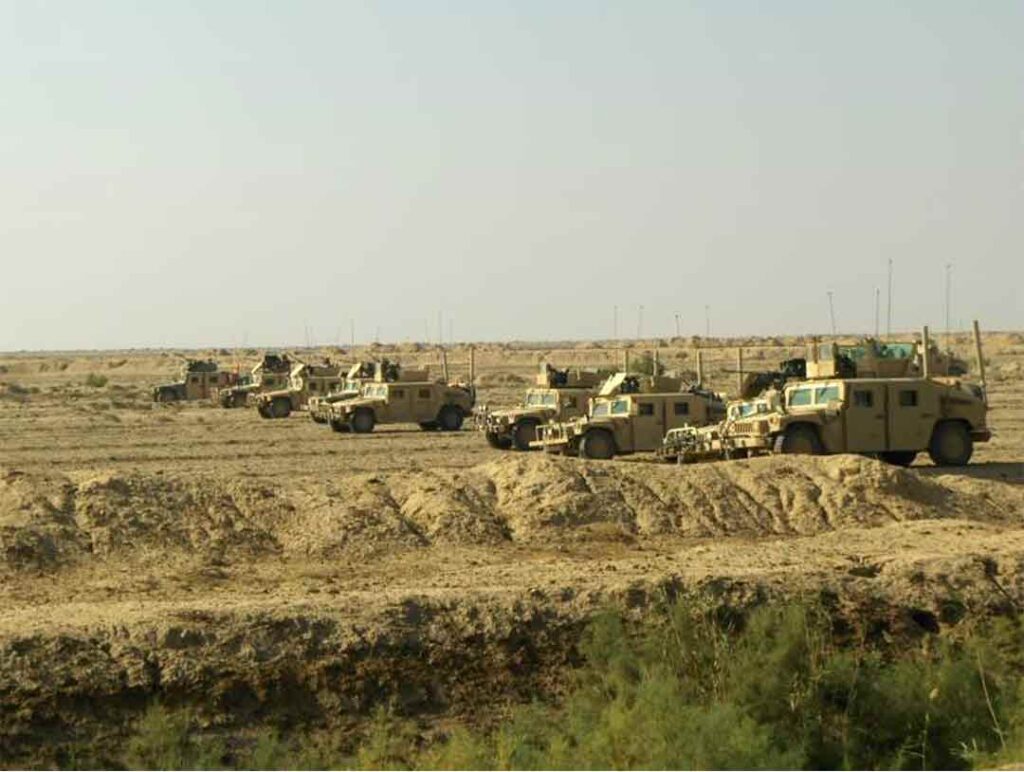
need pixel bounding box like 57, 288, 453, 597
531, 373, 725, 459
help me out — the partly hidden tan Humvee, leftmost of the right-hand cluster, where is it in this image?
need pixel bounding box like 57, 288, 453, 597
473, 364, 609, 451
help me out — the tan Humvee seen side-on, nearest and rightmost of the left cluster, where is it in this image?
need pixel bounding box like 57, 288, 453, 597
328, 368, 476, 434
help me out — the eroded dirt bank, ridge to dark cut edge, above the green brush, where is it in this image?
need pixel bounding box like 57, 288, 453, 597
0, 455, 1024, 765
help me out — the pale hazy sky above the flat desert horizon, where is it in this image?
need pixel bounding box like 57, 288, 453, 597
0, 0, 1024, 349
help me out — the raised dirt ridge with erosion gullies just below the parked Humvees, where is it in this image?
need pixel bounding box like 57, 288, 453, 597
0, 456, 1024, 569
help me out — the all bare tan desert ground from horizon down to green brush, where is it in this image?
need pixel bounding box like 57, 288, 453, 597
0, 333, 1024, 765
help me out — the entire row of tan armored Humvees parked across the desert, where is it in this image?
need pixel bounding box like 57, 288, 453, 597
153, 323, 991, 466
